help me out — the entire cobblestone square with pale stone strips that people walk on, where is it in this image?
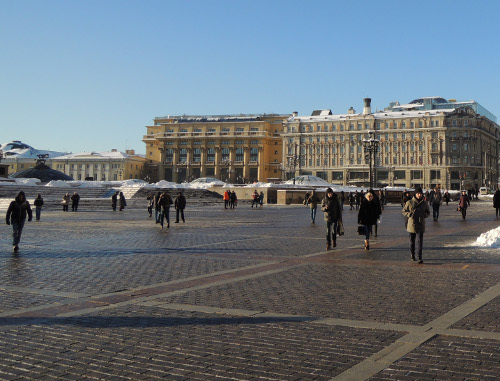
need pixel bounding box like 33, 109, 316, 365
0, 201, 500, 380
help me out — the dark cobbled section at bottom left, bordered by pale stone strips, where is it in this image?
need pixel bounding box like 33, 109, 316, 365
0, 306, 401, 379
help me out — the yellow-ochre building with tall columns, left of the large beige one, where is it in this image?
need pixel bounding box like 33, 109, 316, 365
142, 114, 288, 184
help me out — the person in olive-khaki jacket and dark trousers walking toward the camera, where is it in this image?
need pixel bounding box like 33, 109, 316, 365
402, 187, 431, 263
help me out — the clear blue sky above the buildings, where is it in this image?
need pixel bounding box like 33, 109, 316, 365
0, 0, 500, 153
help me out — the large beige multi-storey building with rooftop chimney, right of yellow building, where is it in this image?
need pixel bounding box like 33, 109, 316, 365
283, 98, 500, 190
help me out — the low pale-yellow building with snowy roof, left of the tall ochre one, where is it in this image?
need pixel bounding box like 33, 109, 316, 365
50, 149, 146, 181
